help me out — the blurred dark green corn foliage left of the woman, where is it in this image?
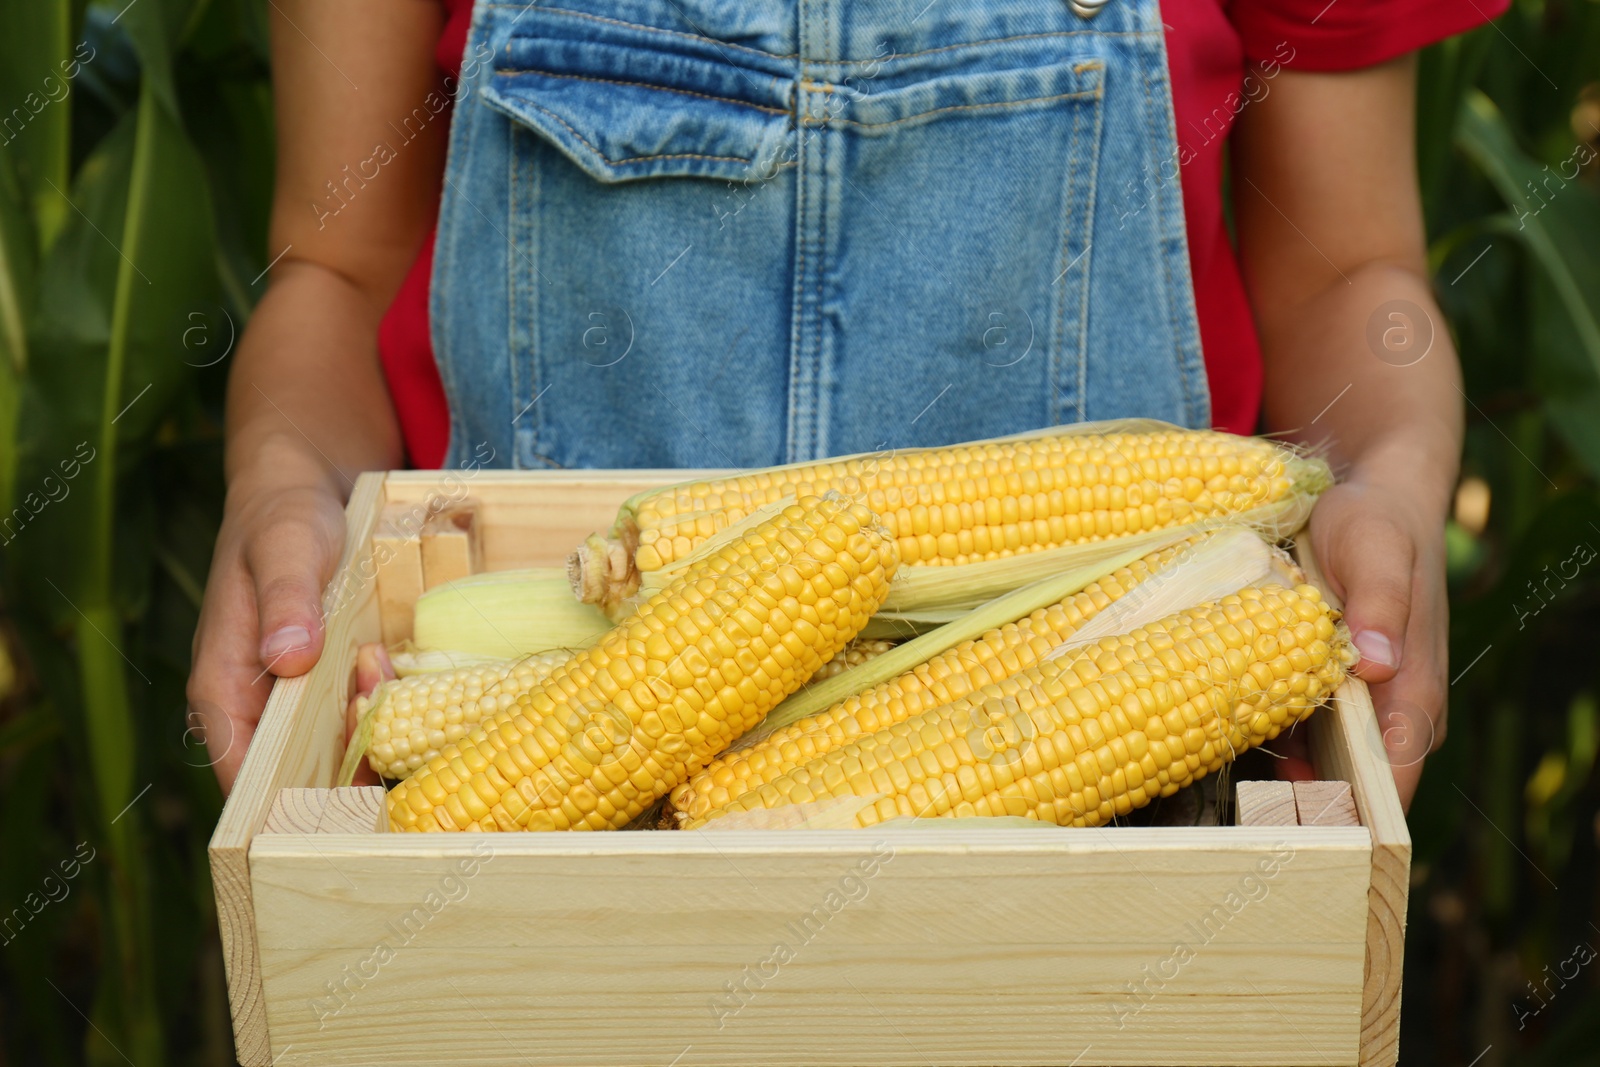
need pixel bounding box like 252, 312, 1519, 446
0, 0, 272, 1064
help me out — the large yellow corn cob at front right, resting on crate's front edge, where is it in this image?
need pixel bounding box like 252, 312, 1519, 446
688, 585, 1350, 829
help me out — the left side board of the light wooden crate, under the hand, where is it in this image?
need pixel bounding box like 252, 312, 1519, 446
208, 474, 384, 1067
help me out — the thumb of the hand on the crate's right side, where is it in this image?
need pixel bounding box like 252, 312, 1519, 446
1322, 515, 1416, 681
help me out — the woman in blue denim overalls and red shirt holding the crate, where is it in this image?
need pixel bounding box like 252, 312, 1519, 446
189, 0, 1506, 800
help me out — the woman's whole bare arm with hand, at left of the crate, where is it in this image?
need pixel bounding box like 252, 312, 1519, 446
189, 0, 450, 790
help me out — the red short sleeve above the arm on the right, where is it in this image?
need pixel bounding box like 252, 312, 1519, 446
1235, 0, 1510, 70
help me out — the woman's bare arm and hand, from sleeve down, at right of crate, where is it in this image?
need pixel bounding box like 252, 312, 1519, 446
1230, 56, 1462, 803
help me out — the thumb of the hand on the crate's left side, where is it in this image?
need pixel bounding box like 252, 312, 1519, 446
245, 517, 333, 677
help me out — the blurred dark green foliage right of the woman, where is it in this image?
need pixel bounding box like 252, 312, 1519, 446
1400, 0, 1600, 1067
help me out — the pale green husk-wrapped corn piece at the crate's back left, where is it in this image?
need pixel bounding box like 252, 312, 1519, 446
411, 566, 611, 665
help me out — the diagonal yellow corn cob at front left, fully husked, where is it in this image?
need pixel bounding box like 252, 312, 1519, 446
380, 496, 898, 830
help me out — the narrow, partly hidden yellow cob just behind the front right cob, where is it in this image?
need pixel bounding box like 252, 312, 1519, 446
672, 541, 1194, 821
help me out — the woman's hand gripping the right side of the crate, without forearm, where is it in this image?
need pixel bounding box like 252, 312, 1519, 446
1310, 458, 1450, 806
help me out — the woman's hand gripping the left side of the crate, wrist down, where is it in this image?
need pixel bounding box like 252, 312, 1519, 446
189, 461, 344, 792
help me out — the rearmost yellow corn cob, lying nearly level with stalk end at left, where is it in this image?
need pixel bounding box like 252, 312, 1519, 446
568, 427, 1328, 614
